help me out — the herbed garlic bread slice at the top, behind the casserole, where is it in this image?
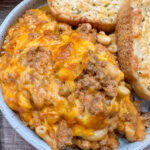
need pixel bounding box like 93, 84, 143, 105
48, 0, 122, 32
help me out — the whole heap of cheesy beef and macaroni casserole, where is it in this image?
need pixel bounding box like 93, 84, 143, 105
0, 9, 147, 150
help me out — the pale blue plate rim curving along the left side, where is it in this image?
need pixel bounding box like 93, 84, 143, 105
0, 0, 52, 150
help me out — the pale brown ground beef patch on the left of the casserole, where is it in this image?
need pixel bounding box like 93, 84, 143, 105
17, 46, 61, 109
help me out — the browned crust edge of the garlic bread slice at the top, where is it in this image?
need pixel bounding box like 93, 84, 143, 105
48, 0, 120, 32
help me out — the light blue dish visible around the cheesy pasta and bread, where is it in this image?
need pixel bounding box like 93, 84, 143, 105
0, 0, 148, 150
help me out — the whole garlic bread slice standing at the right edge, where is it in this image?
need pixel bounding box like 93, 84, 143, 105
116, 0, 150, 100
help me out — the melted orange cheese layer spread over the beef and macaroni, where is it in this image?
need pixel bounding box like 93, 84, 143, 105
0, 8, 145, 146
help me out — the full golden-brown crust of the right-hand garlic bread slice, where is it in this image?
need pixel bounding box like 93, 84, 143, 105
116, 0, 150, 100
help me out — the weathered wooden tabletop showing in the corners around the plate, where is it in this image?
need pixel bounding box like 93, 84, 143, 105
0, 0, 150, 150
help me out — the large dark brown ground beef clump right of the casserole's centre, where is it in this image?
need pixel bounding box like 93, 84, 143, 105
75, 57, 117, 115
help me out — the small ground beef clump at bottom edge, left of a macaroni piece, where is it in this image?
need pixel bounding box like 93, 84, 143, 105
57, 120, 73, 150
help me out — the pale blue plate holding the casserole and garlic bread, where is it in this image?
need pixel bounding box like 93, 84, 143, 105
0, 0, 150, 150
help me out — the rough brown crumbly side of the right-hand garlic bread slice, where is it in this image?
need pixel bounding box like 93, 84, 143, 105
116, 1, 138, 80
